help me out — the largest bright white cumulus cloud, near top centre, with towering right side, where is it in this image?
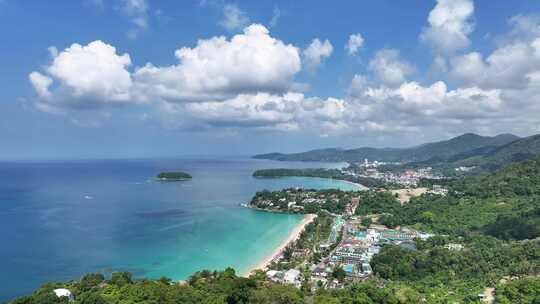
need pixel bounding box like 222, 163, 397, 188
134, 24, 301, 101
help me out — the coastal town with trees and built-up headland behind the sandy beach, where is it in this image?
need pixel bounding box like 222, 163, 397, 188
248, 186, 440, 290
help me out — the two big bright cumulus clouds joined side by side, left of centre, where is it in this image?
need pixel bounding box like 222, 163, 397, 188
29, 24, 301, 108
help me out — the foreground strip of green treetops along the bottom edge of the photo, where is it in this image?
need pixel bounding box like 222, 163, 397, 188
13, 268, 480, 304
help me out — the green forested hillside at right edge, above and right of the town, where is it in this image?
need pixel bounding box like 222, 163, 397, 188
356, 158, 540, 240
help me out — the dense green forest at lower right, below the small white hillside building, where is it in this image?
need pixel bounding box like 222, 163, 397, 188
372, 236, 540, 302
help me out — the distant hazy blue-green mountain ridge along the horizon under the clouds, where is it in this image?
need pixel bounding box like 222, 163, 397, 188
253, 133, 521, 162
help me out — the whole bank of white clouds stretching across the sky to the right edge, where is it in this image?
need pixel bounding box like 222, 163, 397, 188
28, 12, 540, 136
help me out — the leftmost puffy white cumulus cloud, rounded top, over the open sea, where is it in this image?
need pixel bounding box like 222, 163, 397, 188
29, 40, 132, 107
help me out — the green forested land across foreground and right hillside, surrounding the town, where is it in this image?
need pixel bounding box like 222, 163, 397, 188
13, 158, 540, 304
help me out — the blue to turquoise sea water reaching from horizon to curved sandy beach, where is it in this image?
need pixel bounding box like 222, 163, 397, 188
0, 158, 357, 301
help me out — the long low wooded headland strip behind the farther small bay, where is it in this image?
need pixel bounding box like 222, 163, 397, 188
253, 168, 383, 187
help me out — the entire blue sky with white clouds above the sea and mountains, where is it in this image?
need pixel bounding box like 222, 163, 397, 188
0, 0, 540, 159
